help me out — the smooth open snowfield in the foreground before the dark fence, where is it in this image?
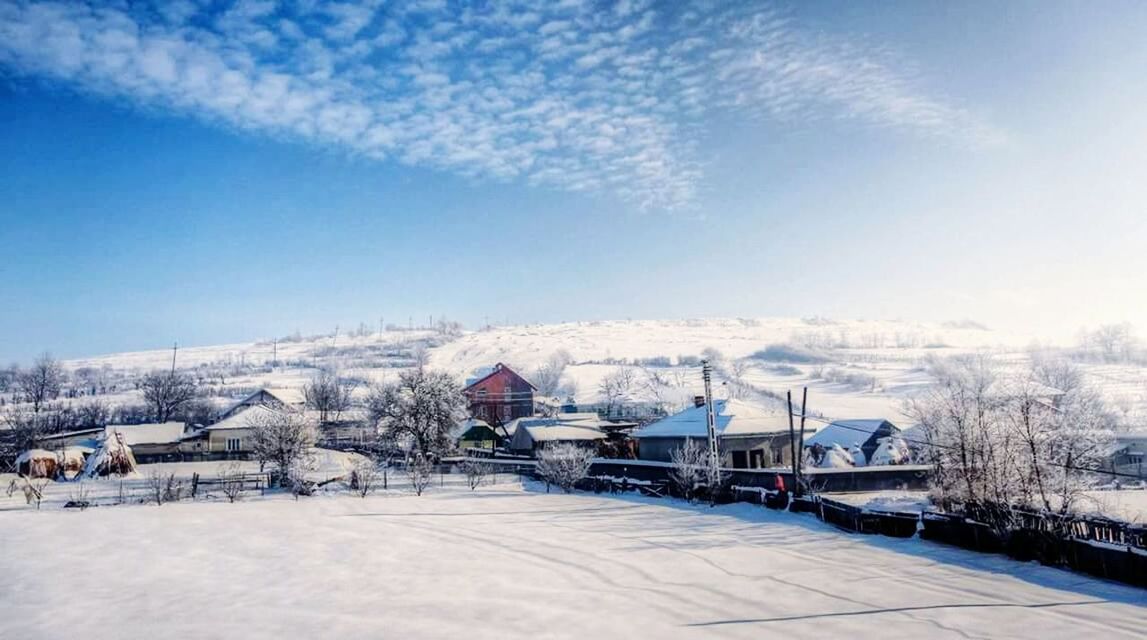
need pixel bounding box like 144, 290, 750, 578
0, 486, 1147, 640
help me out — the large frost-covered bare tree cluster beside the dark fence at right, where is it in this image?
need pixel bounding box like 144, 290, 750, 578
911, 356, 1113, 516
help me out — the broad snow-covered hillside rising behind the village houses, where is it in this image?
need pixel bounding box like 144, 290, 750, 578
55, 318, 1147, 422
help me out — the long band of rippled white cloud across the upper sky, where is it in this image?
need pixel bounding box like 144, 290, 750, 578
0, 0, 998, 209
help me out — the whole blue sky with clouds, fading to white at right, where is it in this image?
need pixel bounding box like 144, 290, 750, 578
0, 0, 1147, 360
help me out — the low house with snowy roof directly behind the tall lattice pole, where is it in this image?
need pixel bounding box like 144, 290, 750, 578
633, 398, 807, 469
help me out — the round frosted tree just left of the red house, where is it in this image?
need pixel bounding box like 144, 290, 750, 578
367, 369, 466, 455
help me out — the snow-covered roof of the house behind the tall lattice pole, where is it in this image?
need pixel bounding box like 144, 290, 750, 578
633, 400, 809, 438
